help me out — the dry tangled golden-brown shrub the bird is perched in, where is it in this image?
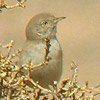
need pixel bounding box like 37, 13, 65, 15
0, 39, 100, 100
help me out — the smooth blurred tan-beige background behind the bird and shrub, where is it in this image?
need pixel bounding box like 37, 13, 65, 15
0, 0, 100, 95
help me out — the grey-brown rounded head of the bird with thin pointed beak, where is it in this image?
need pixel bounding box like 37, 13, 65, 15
26, 13, 65, 40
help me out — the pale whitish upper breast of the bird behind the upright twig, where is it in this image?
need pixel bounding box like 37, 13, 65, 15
20, 40, 62, 64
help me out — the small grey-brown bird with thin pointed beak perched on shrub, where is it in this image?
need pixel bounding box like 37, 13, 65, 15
20, 13, 65, 88
